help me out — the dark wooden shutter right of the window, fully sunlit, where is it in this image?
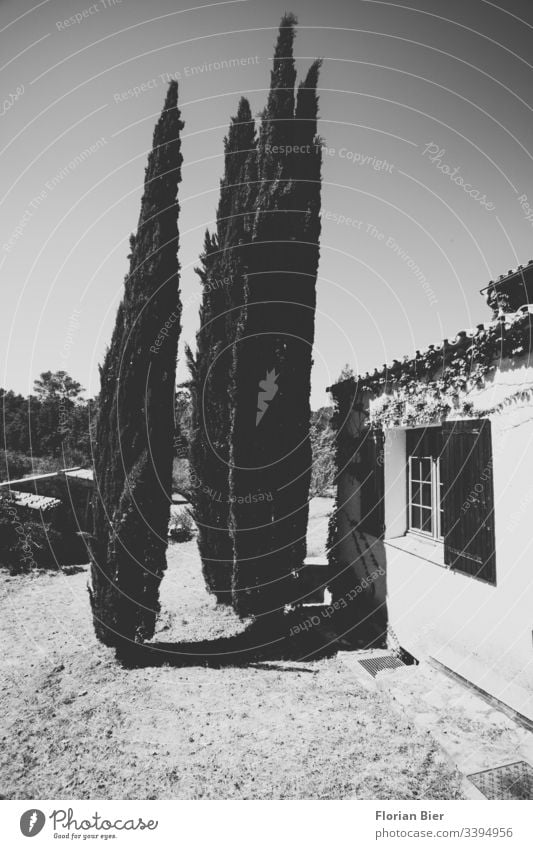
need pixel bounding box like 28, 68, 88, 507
441, 419, 496, 584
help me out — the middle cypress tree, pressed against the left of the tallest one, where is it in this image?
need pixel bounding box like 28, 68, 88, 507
189, 98, 256, 604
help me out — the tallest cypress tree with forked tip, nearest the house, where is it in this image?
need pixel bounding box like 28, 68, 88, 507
230, 15, 321, 615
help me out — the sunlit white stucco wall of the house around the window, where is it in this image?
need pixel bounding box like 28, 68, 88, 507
337, 358, 533, 719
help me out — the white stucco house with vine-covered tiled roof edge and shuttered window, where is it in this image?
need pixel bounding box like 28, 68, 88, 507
330, 262, 533, 720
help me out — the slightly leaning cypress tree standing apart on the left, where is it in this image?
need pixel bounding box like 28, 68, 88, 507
90, 82, 183, 646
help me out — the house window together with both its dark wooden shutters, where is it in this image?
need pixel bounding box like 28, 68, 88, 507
357, 419, 496, 584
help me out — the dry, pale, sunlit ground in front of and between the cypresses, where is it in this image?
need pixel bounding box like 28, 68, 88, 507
0, 541, 459, 799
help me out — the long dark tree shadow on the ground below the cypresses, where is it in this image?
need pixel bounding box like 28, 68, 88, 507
116, 606, 386, 671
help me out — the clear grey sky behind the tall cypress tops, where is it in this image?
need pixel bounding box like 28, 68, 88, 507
0, 0, 533, 408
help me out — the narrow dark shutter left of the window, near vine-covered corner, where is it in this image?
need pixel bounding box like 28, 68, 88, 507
360, 428, 385, 537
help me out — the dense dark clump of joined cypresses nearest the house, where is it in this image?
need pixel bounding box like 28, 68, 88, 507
189, 15, 321, 616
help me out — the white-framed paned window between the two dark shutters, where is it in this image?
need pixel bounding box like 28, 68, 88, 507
407, 428, 443, 540
